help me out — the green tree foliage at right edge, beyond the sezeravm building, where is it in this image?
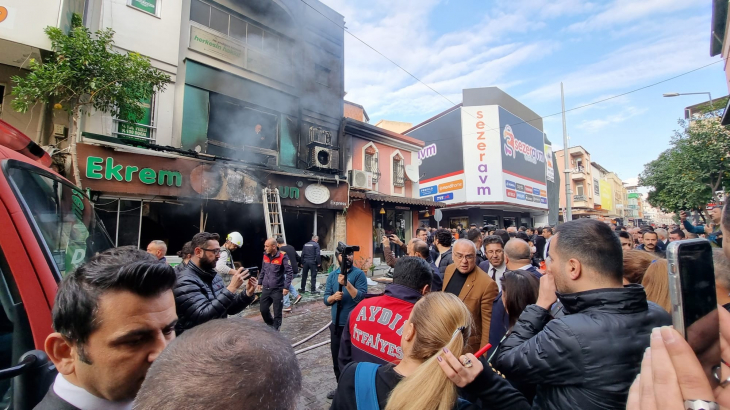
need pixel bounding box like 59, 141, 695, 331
639, 117, 730, 212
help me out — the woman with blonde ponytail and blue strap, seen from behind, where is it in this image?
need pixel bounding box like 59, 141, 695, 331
331, 292, 529, 410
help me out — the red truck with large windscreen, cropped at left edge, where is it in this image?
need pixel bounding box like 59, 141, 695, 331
0, 120, 113, 410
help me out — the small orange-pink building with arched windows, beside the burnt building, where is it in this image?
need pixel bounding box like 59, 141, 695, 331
343, 103, 443, 263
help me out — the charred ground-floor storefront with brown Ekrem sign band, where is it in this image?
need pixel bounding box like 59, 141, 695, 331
78, 144, 347, 266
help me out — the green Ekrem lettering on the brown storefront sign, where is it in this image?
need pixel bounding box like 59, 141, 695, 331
86, 156, 182, 187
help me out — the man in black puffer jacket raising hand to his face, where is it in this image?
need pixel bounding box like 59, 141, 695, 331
494, 219, 672, 410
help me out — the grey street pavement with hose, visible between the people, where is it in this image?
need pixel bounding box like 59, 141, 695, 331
236, 265, 388, 410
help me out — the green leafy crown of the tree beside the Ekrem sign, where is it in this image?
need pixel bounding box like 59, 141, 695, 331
12, 20, 170, 121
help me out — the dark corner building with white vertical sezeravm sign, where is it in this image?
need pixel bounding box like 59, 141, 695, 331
404, 87, 559, 231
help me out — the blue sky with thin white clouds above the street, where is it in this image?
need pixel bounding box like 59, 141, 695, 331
321, 0, 728, 180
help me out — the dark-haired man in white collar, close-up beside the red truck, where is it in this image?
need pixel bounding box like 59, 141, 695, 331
35, 246, 177, 410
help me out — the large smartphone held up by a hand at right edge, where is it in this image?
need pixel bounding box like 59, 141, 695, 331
667, 238, 721, 387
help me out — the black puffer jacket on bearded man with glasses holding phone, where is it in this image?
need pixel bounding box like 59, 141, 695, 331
173, 261, 253, 335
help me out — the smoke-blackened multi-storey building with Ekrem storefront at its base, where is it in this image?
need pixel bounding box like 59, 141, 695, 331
61, 0, 349, 266
